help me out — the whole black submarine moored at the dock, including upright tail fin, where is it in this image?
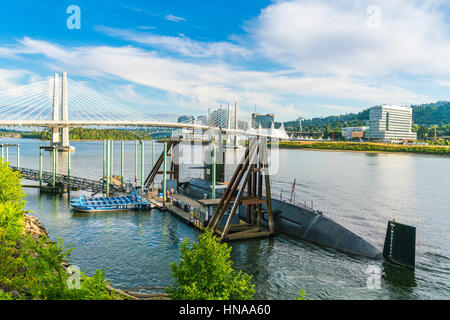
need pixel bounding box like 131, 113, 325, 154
147, 138, 416, 270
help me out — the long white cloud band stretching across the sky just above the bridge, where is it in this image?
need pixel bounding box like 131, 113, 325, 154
5, 38, 426, 120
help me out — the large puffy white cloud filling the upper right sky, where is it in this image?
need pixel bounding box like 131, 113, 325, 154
246, 0, 450, 78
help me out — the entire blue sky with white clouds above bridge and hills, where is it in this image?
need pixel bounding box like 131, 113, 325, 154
0, 0, 450, 120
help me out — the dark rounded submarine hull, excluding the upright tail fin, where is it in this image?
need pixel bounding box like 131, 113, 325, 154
182, 179, 382, 258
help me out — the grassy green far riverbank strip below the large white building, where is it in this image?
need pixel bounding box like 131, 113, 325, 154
279, 141, 450, 155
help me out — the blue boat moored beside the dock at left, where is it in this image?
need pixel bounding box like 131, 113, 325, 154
70, 192, 153, 212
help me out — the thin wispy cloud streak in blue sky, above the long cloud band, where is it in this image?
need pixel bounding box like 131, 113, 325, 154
96, 26, 251, 58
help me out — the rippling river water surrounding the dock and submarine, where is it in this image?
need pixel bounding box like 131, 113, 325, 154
0, 139, 450, 299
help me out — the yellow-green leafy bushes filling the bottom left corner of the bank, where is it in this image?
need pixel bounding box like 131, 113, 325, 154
0, 163, 118, 300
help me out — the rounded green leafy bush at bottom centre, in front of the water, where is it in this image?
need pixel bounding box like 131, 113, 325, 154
167, 229, 255, 300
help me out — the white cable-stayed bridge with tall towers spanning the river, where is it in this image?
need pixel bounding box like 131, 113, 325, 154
0, 72, 287, 148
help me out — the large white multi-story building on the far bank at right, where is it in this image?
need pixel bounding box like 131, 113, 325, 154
365, 105, 417, 142
